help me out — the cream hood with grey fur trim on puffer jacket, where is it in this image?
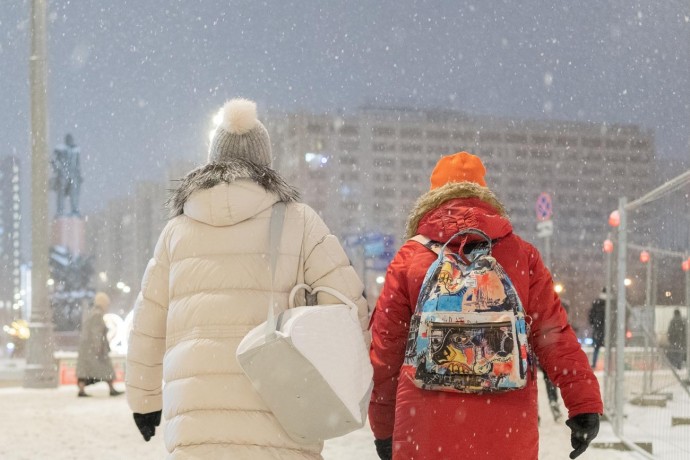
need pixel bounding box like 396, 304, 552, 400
167, 158, 299, 225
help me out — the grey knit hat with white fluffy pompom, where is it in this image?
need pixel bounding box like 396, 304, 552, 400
208, 99, 272, 166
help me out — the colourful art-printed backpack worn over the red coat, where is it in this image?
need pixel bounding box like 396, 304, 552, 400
403, 229, 531, 393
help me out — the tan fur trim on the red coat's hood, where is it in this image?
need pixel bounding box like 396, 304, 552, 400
405, 182, 508, 239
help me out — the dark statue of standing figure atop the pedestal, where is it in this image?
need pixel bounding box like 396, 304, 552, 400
51, 134, 82, 216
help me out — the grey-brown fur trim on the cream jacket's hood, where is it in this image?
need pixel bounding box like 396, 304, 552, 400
166, 158, 299, 218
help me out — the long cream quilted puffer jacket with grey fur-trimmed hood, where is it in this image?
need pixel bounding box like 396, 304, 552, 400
126, 161, 368, 460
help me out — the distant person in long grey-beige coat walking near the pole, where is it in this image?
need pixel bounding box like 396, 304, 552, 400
77, 292, 122, 397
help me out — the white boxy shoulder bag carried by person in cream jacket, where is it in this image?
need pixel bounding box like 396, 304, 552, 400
236, 203, 373, 443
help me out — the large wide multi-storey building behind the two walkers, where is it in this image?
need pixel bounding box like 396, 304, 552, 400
265, 108, 655, 318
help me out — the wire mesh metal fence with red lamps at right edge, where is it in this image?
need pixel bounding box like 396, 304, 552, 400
603, 171, 690, 460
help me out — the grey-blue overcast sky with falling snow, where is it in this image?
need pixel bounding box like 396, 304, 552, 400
0, 0, 690, 212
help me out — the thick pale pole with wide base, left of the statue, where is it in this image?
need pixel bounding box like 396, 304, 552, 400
23, 0, 58, 388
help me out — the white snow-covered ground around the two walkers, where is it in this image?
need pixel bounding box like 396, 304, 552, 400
0, 370, 656, 460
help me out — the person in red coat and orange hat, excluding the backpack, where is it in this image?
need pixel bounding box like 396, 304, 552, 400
369, 152, 603, 460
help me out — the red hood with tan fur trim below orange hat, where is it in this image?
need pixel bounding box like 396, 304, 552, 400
405, 182, 512, 240
